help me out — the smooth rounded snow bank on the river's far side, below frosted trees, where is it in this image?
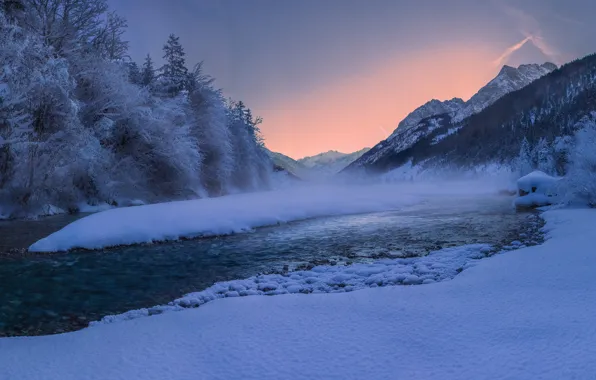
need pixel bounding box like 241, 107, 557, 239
29, 183, 494, 252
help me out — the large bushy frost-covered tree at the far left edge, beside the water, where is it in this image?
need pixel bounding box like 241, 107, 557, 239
0, 19, 96, 214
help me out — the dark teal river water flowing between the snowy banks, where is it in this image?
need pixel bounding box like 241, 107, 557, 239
0, 197, 538, 336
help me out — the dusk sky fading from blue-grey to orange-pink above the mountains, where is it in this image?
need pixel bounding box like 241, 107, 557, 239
109, 0, 596, 158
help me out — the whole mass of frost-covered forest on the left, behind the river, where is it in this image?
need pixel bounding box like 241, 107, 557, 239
0, 0, 272, 216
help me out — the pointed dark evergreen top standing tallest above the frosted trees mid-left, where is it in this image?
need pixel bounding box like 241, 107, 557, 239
160, 34, 189, 97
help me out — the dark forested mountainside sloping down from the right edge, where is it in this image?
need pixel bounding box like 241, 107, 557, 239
349, 55, 596, 174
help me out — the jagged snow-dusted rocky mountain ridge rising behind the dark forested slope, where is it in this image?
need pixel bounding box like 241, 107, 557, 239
349, 62, 557, 170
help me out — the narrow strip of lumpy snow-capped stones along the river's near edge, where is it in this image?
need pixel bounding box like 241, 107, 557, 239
91, 243, 494, 325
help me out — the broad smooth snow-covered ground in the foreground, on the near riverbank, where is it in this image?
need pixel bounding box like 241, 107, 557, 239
0, 209, 596, 380
